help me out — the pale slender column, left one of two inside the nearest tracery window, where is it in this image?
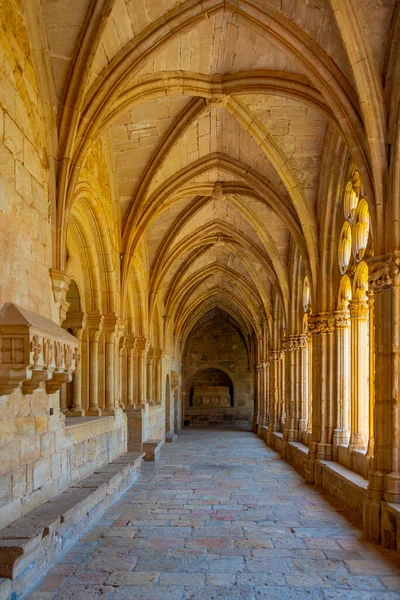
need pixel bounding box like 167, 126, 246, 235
333, 310, 351, 460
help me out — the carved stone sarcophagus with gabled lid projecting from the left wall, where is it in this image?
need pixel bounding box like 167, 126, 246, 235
0, 302, 79, 395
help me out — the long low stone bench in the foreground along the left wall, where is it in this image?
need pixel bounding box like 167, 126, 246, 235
0, 452, 143, 600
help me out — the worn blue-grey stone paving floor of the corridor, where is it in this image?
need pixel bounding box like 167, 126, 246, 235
26, 430, 400, 600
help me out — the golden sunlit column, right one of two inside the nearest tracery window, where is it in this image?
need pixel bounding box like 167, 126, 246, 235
349, 300, 369, 450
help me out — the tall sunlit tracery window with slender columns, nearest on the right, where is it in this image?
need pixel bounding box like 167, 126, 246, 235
338, 170, 372, 450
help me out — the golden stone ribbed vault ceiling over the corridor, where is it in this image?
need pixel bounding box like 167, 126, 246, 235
42, 0, 394, 346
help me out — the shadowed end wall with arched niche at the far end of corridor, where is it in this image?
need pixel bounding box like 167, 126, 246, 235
182, 315, 253, 428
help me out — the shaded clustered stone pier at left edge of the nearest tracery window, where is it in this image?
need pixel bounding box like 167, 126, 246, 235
306, 312, 336, 472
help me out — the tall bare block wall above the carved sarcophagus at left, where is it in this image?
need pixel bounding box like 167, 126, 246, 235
0, 0, 52, 317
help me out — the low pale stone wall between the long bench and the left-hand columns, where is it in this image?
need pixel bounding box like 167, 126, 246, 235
0, 406, 126, 528
